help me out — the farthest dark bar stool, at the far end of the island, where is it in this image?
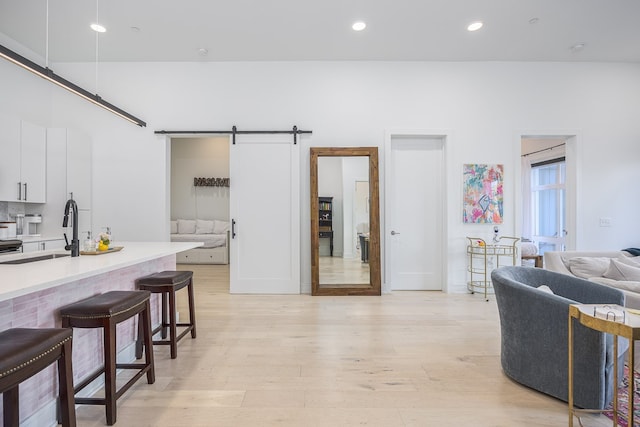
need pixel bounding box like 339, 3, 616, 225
136, 271, 196, 359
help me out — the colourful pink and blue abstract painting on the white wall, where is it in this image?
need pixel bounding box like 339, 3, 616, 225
462, 164, 504, 224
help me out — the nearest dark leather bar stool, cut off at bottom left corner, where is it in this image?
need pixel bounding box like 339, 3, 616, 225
0, 328, 76, 427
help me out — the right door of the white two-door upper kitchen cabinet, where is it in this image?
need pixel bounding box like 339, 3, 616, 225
20, 121, 47, 203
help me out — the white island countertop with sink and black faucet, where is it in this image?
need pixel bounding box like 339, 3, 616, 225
0, 242, 202, 301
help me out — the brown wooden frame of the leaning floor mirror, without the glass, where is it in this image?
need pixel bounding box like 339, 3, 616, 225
310, 147, 381, 295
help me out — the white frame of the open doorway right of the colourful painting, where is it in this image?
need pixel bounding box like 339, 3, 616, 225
513, 129, 584, 251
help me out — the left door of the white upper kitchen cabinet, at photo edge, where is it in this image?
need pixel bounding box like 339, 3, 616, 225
0, 114, 20, 202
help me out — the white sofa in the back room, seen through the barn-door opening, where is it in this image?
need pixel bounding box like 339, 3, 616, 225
171, 219, 229, 264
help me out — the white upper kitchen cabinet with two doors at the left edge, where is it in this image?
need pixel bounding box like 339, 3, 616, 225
0, 115, 47, 203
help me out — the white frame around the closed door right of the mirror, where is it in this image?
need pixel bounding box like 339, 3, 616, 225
380, 129, 453, 293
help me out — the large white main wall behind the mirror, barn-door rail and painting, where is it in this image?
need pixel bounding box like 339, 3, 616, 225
0, 46, 640, 291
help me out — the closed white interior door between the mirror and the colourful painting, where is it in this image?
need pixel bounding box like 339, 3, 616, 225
385, 135, 444, 290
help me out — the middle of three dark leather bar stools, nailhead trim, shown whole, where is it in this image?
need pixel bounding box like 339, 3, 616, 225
60, 291, 155, 425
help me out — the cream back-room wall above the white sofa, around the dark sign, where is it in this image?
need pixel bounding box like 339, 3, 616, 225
171, 136, 229, 221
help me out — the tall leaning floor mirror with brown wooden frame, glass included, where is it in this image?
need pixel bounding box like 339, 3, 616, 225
310, 147, 381, 295
